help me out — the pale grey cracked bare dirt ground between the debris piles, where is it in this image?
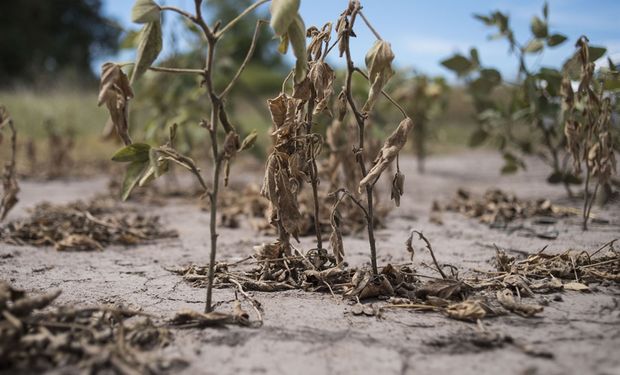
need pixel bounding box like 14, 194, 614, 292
0, 152, 620, 375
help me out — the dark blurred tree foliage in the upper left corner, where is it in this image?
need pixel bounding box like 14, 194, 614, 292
0, 0, 120, 84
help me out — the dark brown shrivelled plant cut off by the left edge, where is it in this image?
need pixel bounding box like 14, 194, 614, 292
0, 105, 19, 221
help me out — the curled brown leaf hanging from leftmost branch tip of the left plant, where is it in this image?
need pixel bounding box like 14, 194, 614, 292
98, 63, 133, 145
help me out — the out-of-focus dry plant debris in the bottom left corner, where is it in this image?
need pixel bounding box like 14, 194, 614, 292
0, 280, 184, 375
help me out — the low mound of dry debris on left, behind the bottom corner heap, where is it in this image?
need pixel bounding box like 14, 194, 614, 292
0, 197, 177, 250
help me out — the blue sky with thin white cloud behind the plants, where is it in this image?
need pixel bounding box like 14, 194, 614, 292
104, 0, 620, 77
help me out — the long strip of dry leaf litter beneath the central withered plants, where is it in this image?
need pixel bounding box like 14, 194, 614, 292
170, 232, 620, 328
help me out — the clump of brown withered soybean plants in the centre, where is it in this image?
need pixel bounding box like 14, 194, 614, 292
263, 0, 413, 275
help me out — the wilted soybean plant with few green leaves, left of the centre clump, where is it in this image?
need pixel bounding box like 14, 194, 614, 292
99, 0, 267, 312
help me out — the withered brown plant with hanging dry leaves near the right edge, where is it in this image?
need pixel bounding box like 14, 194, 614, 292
562, 36, 616, 230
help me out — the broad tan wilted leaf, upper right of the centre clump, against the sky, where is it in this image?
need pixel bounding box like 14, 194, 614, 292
362, 40, 394, 112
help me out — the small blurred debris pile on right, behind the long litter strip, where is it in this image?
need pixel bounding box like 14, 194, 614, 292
438, 188, 578, 227
